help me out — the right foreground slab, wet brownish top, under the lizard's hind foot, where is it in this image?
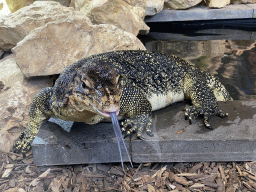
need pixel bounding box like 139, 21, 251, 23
132, 101, 256, 163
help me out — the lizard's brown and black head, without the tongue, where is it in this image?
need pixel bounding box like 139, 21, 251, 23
70, 64, 122, 118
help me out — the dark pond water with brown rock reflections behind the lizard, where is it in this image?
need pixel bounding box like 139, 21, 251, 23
141, 29, 256, 100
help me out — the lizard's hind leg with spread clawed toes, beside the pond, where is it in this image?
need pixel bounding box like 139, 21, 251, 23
184, 70, 232, 129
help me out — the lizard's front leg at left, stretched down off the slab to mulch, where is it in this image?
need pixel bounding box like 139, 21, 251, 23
14, 87, 52, 153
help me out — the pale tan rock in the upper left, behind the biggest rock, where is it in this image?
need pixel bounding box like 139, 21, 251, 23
0, 1, 90, 50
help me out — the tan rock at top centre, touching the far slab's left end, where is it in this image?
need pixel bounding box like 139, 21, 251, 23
75, 0, 149, 35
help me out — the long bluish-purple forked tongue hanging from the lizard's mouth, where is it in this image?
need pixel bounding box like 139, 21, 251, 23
109, 112, 133, 170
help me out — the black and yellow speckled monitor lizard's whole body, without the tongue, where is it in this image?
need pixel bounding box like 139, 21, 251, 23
14, 50, 232, 152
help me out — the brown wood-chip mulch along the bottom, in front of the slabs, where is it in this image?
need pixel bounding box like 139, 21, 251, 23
0, 152, 256, 192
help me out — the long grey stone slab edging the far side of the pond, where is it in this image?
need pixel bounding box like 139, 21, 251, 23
145, 4, 255, 23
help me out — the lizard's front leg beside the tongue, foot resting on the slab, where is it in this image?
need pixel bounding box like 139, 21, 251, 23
120, 86, 153, 139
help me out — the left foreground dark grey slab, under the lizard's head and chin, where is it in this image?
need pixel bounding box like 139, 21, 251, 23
32, 122, 130, 166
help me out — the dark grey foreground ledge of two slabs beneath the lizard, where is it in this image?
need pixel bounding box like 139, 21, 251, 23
32, 100, 256, 165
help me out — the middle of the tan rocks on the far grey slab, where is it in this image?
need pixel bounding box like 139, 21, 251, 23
165, 0, 202, 9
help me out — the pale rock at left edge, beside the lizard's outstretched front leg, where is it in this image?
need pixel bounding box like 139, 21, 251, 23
0, 55, 52, 152
